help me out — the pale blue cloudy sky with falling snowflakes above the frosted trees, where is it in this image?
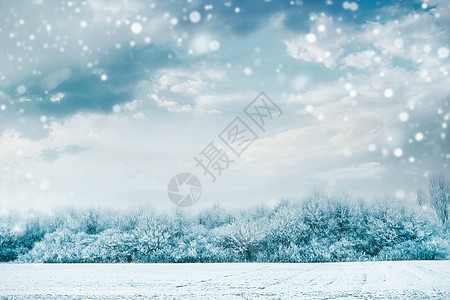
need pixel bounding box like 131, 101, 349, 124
0, 0, 450, 212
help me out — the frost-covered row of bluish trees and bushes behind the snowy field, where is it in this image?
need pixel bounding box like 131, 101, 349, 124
0, 175, 450, 263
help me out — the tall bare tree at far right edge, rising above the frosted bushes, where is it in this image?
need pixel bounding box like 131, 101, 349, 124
429, 174, 450, 224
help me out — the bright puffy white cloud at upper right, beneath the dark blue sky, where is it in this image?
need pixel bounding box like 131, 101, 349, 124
284, 7, 450, 69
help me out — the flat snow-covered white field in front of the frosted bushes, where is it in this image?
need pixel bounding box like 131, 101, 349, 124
0, 261, 450, 299
